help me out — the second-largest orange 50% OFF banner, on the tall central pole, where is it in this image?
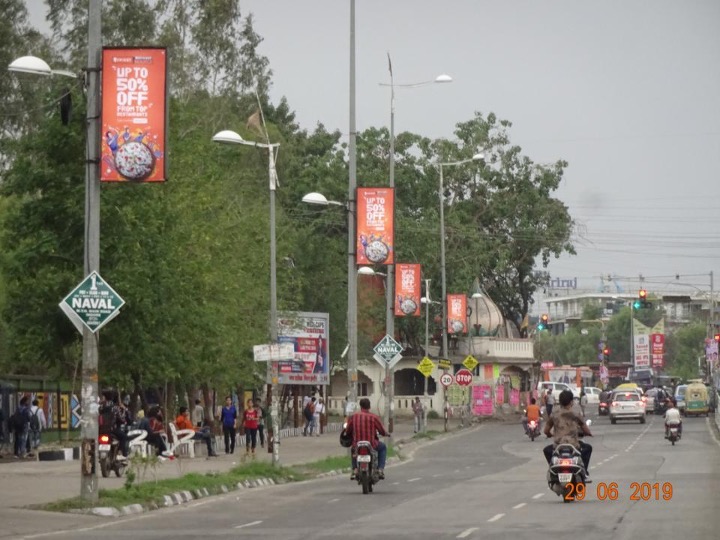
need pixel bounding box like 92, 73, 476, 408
355, 188, 395, 264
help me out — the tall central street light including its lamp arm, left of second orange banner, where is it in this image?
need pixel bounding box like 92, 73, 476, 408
302, 189, 356, 415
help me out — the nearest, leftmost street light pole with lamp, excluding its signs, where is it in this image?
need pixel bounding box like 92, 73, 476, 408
8, 0, 102, 502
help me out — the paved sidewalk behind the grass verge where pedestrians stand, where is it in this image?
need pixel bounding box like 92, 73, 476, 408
0, 418, 458, 508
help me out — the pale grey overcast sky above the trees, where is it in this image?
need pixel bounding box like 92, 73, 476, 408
28, 0, 720, 312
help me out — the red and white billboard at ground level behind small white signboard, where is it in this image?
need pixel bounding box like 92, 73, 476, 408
268, 311, 330, 385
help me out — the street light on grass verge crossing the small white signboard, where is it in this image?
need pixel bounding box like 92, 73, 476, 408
212, 130, 280, 465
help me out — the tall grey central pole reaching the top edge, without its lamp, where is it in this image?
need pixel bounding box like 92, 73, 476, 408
344, 0, 357, 414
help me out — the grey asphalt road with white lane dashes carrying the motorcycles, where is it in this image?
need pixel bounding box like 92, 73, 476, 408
7, 416, 720, 540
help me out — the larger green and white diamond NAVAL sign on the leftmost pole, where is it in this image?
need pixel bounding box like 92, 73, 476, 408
60, 272, 125, 333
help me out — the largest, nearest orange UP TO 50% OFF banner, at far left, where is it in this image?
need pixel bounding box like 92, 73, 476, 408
100, 48, 167, 182
